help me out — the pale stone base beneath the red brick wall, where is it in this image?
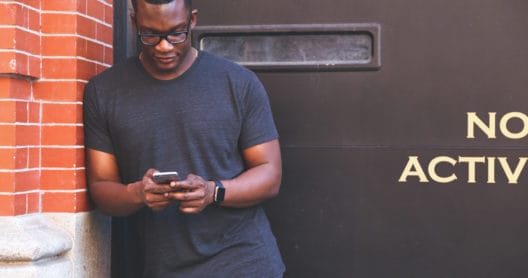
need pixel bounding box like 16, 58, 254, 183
0, 211, 111, 277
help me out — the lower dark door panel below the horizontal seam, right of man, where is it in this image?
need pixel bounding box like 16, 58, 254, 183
266, 148, 528, 277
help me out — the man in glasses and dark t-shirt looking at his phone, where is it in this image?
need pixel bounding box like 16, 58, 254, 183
84, 0, 284, 277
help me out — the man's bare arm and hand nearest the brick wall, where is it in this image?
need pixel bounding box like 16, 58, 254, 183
86, 149, 170, 216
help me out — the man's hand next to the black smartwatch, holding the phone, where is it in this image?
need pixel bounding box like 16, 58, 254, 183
165, 174, 215, 214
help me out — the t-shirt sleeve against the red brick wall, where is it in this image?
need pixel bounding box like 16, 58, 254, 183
83, 81, 114, 153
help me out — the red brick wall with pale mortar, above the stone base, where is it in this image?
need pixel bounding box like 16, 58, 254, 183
0, 0, 113, 216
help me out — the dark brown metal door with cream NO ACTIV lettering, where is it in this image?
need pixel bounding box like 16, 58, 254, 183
118, 0, 528, 278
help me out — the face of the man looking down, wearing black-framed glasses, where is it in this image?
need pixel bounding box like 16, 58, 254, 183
132, 0, 196, 79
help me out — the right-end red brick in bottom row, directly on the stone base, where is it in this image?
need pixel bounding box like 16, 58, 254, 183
42, 191, 90, 212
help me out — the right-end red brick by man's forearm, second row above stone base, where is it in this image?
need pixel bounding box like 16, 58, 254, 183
40, 169, 86, 190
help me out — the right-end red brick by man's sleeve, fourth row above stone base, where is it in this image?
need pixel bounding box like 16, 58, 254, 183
42, 125, 84, 146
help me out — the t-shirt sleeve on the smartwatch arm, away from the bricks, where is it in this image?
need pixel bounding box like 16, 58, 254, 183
239, 75, 279, 149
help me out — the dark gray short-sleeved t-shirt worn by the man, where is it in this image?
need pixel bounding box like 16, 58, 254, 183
84, 52, 284, 277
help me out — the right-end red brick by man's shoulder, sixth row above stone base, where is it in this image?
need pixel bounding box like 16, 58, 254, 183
33, 81, 85, 101
